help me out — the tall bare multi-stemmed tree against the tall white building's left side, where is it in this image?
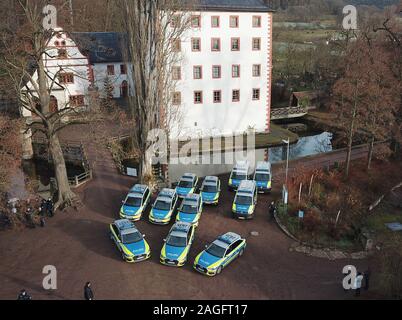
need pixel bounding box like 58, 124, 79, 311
120, 0, 195, 179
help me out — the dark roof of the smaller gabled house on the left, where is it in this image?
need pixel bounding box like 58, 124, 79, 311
71, 32, 128, 64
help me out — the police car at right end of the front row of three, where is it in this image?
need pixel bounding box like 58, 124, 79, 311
194, 232, 246, 277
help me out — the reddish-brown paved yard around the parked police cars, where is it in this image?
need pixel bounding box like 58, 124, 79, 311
0, 159, 364, 299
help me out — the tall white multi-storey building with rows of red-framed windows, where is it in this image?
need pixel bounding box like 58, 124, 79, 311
172, 0, 272, 136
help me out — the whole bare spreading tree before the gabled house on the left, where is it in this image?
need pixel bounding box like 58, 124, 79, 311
0, 0, 103, 206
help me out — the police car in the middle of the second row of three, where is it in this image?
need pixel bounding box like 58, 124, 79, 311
149, 188, 178, 225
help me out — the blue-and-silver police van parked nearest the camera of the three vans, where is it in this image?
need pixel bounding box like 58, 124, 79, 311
232, 180, 258, 219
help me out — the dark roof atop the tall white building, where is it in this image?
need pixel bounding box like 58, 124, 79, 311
183, 0, 274, 12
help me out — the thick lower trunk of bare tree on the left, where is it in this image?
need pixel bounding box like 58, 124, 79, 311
49, 134, 77, 208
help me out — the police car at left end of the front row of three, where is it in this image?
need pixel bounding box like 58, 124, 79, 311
109, 219, 151, 263
